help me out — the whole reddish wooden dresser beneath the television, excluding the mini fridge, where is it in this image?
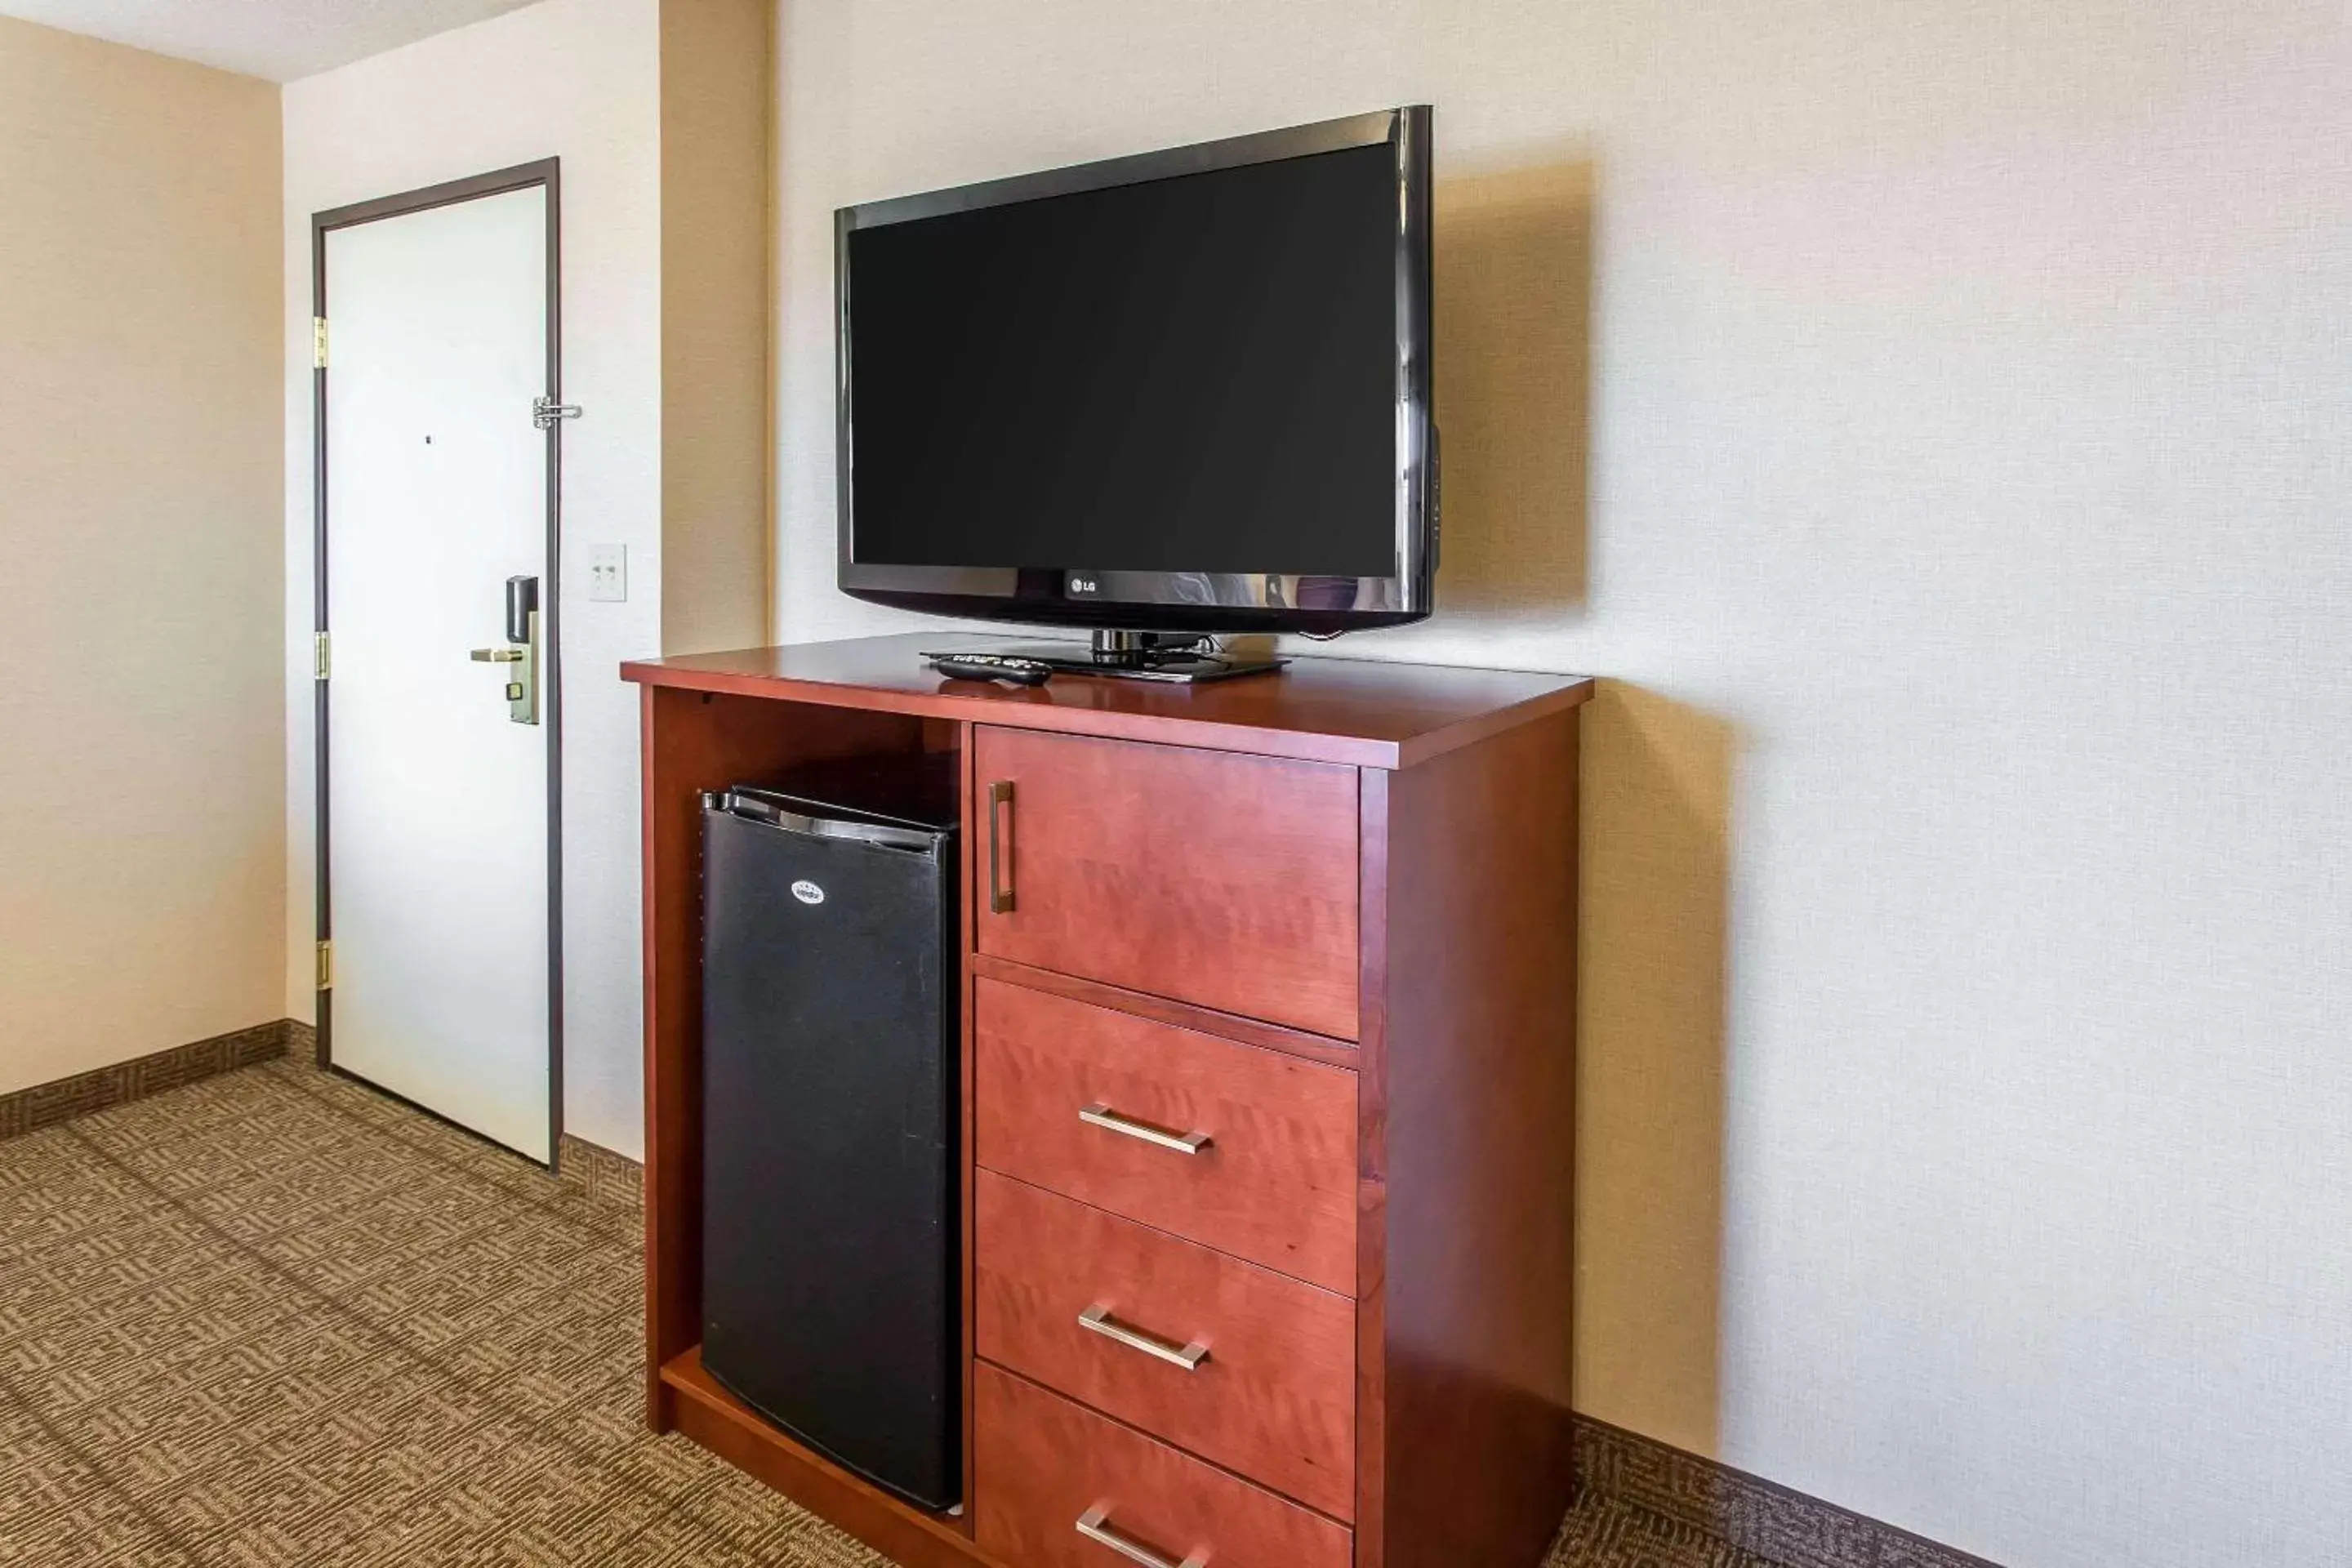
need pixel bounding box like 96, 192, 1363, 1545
623, 632, 1592, 1568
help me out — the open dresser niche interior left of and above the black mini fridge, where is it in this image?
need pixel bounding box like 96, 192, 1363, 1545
639, 687, 945, 1432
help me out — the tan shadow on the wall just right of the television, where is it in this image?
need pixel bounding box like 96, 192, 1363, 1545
1430, 160, 1595, 616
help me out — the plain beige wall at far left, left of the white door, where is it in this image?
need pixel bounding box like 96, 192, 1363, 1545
0, 19, 284, 1091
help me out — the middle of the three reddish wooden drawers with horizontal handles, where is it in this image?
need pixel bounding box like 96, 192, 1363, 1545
971, 1171, 1355, 1519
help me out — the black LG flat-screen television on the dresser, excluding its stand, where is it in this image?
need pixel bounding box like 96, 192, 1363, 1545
835, 106, 1437, 635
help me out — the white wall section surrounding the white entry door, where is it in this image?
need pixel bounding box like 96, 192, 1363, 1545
284, 0, 661, 1154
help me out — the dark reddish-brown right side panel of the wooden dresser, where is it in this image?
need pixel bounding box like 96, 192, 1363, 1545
1366, 712, 1576, 1568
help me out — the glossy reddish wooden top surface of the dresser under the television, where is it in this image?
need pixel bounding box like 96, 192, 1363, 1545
621, 632, 1592, 768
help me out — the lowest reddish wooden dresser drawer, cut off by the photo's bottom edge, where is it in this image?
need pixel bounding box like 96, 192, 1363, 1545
971, 1361, 1355, 1568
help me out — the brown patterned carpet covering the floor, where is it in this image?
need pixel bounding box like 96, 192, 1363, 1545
0, 1060, 1762, 1568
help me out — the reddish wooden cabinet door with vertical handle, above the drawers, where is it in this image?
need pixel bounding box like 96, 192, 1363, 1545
971, 726, 1357, 1039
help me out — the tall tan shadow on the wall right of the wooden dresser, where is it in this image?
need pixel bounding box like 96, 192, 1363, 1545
1576, 682, 1738, 1458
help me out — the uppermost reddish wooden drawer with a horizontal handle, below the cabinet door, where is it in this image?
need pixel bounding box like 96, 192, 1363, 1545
971, 980, 1357, 1300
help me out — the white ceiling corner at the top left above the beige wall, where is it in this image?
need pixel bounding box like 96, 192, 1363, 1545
0, 0, 532, 82
